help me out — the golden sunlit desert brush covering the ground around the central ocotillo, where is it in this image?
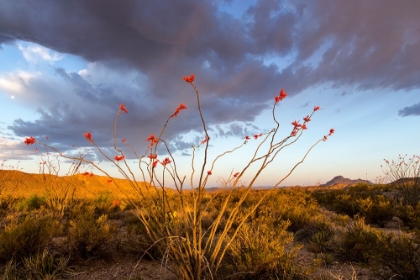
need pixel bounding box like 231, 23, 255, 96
0, 171, 420, 279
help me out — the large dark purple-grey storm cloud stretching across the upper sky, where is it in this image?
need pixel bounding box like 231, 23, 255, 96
0, 0, 420, 155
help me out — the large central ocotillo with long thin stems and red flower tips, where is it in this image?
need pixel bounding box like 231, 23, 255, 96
24, 75, 334, 279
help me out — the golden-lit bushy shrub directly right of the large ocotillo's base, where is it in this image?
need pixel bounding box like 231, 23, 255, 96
221, 220, 304, 279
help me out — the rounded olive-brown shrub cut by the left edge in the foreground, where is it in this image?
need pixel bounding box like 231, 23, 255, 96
0, 215, 60, 261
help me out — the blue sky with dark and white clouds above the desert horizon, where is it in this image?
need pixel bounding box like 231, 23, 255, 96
0, 0, 420, 186
